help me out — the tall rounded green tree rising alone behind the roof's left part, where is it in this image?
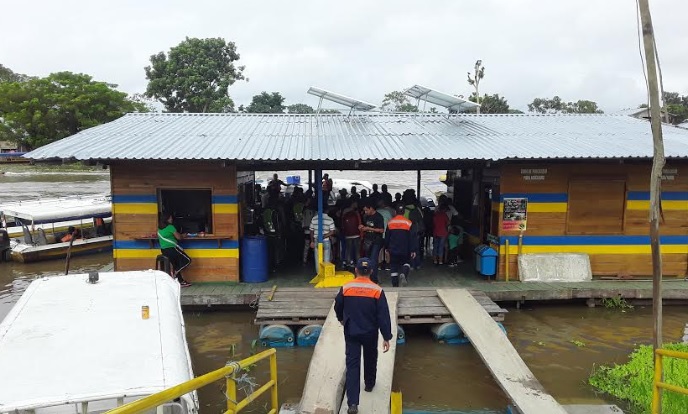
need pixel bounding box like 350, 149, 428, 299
145, 37, 248, 112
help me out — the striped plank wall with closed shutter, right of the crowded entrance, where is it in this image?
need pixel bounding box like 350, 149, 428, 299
499, 162, 688, 279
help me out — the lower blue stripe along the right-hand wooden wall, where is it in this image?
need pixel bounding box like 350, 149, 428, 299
499, 236, 688, 246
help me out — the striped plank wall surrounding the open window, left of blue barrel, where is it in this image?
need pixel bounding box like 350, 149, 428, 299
110, 161, 239, 282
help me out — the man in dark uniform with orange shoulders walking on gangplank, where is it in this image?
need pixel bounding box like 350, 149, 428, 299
334, 257, 392, 414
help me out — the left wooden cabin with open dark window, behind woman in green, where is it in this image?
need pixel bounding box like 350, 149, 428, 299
110, 161, 239, 282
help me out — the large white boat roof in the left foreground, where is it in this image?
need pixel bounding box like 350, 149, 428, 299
0, 270, 199, 414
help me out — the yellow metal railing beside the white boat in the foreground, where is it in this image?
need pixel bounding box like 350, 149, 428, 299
108, 348, 279, 414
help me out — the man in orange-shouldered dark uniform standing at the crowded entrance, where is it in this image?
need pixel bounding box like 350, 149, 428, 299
385, 205, 419, 287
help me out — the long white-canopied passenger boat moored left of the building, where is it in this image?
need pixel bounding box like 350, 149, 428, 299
0, 195, 112, 263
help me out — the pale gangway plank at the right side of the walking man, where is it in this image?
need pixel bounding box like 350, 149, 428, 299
339, 292, 399, 414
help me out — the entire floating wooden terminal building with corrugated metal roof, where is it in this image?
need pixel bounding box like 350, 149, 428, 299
28, 113, 688, 281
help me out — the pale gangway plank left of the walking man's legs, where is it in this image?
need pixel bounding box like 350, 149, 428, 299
299, 302, 346, 414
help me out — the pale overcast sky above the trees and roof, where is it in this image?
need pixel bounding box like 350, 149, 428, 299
0, 0, 688, 112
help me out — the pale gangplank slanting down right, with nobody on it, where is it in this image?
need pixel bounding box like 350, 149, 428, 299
437, 289, 566, 414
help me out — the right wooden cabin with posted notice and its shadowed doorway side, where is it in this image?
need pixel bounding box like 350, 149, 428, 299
452, 160, 688, 280
